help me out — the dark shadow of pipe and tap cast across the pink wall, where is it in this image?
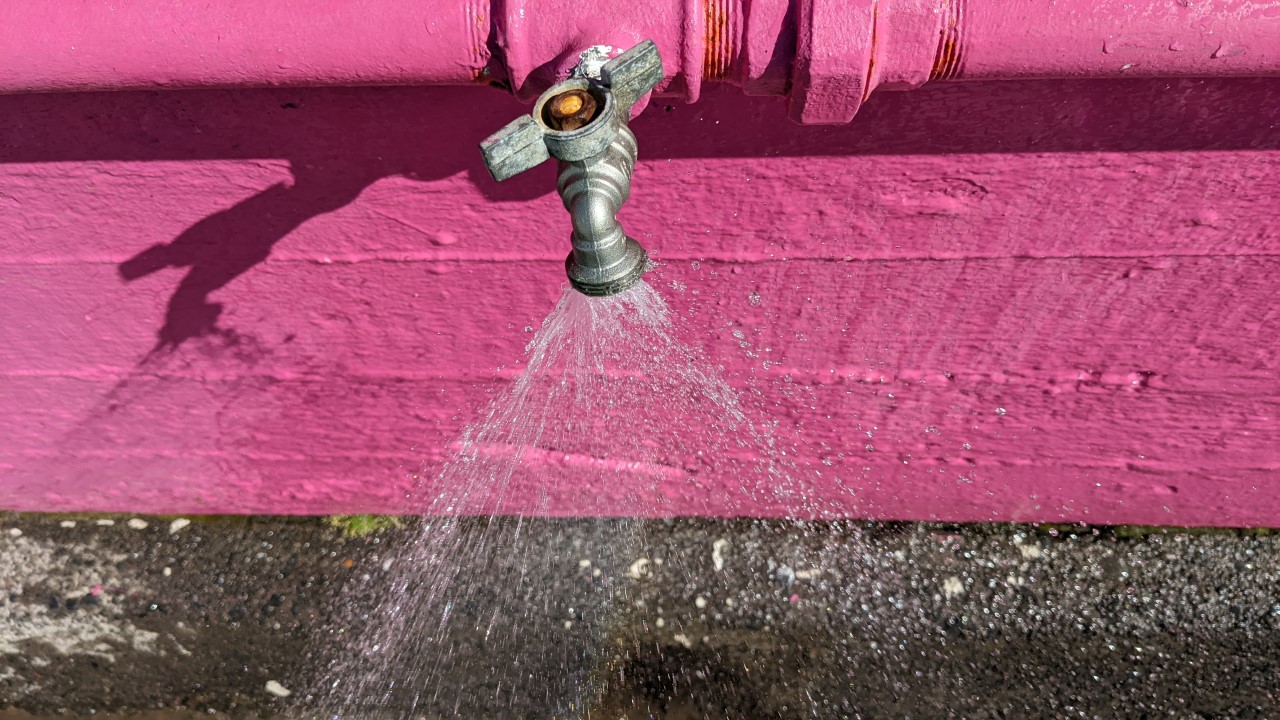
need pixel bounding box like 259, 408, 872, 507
0, 79, 1280, 352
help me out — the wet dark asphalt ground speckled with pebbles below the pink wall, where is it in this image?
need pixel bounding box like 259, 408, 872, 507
0, 515, 1280, 720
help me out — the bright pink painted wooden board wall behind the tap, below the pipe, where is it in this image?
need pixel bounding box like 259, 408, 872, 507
0, 79, 1280, 525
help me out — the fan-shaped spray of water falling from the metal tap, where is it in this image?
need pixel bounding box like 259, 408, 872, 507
308, 283, 796, 717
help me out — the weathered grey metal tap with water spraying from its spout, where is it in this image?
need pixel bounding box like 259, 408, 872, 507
480, 40, 662, 295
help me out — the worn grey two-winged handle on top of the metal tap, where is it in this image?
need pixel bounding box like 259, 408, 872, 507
480, 40, 662, 182
